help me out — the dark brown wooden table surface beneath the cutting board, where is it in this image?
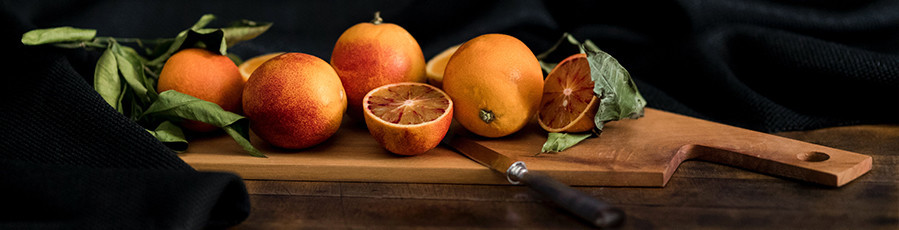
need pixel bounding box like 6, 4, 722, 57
235, 125, 899, 229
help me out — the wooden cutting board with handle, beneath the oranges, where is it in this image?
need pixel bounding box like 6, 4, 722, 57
180, 108, 872, 187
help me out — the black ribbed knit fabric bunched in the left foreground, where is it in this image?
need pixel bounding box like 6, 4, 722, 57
0, 2, 249, 229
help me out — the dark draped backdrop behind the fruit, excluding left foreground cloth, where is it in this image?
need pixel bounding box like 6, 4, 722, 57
6, 0, 899, 132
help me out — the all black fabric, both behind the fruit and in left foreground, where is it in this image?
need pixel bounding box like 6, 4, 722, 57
0, 0, 899, 229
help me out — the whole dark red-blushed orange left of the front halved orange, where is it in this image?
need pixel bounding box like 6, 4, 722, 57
243, 53, 346, 149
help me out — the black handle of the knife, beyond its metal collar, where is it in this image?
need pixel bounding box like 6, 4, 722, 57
516, 171, 624, 228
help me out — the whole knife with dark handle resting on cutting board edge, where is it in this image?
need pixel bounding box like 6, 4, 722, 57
443, 131, 625, 228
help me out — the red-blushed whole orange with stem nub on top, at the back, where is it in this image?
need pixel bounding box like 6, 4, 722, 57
331, 13, 426, 119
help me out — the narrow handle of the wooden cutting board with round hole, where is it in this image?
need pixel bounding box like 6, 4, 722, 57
678, 141, 872, 187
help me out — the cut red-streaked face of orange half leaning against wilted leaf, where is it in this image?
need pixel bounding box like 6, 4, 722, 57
539, 55, 593, 128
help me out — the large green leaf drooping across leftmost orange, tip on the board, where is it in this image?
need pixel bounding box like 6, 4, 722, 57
143, 90, 265, 157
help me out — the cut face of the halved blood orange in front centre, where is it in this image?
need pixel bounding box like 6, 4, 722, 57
366, 85, 449, 125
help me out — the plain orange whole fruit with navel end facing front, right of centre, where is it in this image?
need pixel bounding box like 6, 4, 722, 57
443, 34, 543, 137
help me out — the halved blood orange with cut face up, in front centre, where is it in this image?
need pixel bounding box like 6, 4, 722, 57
362, 82, 453, 155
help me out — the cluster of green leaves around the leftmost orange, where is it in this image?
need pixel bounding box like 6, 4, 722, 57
22, 14, 272, 157
